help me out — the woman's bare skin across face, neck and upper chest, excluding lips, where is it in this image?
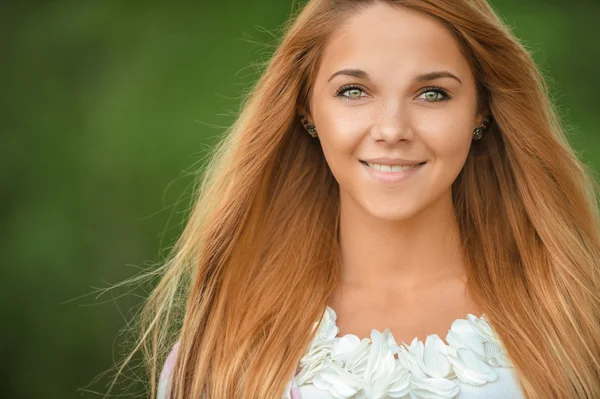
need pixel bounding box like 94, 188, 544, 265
299, 3, 487, 343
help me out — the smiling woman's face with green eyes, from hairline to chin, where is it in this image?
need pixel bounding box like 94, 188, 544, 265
300, 3, 483, 220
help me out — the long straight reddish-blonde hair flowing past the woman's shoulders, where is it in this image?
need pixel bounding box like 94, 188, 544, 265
112, 0, 600, 399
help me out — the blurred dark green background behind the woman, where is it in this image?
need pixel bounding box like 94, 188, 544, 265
0, 0, 600, 398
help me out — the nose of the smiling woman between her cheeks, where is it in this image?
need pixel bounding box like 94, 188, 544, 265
372, 101, 413, 144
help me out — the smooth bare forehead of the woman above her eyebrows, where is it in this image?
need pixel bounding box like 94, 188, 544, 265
319, 2, 470, 83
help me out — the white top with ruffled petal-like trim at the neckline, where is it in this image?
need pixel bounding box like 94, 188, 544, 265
282, 306, 525, 399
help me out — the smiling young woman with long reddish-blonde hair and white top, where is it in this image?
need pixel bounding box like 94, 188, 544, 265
130, 0, 600, 399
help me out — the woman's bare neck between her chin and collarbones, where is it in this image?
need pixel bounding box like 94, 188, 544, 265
339, 188, 465, 292
